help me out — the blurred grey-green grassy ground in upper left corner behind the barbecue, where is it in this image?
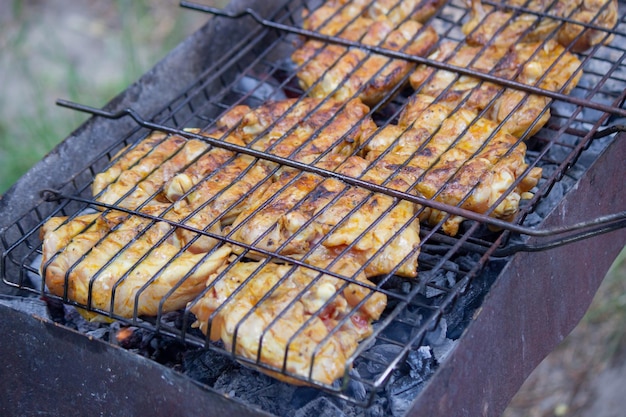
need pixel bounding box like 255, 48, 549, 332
0, 0, 227, 195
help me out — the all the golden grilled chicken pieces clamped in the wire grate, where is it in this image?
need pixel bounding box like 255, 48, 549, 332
41, 0, 616, 384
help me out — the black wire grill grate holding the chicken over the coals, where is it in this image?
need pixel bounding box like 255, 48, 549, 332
2, 1, 626, 405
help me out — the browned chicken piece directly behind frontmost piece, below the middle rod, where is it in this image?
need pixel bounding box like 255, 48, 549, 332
231, 156, 419, 277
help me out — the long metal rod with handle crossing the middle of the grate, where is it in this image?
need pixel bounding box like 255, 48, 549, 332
56, 99, 626, 256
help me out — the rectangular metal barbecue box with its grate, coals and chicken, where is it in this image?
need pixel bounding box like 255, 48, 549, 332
0, 0, 626, 416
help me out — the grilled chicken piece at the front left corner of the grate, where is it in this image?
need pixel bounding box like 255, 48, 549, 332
41, 212, 231, 318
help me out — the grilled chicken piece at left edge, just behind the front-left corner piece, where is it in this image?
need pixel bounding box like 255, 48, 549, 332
92, 129, 245, 209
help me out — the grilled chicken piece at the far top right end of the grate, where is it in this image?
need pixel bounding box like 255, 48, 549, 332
462, 0, 618, 52
